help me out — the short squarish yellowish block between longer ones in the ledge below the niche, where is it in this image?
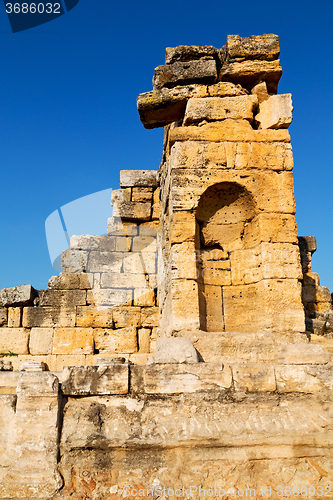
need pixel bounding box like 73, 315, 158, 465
231, 363, 276, 392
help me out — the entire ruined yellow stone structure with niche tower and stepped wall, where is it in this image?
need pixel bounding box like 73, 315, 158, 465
0, 35, 333, 500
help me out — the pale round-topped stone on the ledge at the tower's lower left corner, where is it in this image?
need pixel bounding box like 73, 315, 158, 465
150, 337, 199, 364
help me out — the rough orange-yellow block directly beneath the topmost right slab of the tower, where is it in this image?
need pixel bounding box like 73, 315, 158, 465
219, 59, 282, 94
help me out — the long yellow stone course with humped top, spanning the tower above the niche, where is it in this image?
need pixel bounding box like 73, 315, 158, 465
169, 118, 290, 146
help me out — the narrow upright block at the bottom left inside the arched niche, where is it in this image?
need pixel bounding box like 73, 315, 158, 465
199, 284, 224, 332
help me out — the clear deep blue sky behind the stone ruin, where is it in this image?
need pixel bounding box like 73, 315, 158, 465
0, 0, 333, 291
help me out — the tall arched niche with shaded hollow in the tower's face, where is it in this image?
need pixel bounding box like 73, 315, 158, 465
196, 182, 257, 332
